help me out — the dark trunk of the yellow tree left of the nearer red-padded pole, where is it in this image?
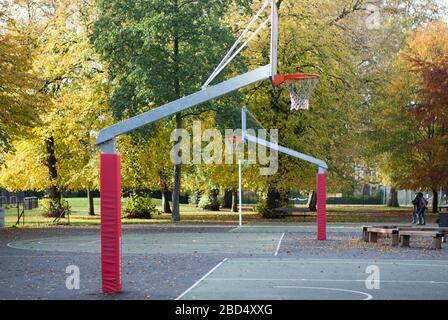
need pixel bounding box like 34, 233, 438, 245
45, 136, 65, 217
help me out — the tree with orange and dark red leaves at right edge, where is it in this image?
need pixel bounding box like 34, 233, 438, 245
402, 20, 448, 212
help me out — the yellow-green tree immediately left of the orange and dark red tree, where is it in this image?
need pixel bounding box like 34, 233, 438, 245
354, 0, 442, 206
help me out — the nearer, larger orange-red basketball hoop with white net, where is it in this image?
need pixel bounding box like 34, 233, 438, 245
272, 73, 319, 110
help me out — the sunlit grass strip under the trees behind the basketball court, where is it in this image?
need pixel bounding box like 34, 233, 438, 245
1, 198, 426, 227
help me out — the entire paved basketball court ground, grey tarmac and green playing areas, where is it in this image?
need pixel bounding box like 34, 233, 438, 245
0, 223, 448, 300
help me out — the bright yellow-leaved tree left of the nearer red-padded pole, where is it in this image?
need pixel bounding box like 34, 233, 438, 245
0, 0, 110, 215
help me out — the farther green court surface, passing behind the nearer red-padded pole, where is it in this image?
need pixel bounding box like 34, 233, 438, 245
8, 232, 282, 254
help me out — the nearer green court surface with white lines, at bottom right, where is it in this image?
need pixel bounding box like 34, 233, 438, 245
177, 258, 448, 300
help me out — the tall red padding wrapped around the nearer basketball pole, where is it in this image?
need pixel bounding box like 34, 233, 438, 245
100, 153, 122, 293
